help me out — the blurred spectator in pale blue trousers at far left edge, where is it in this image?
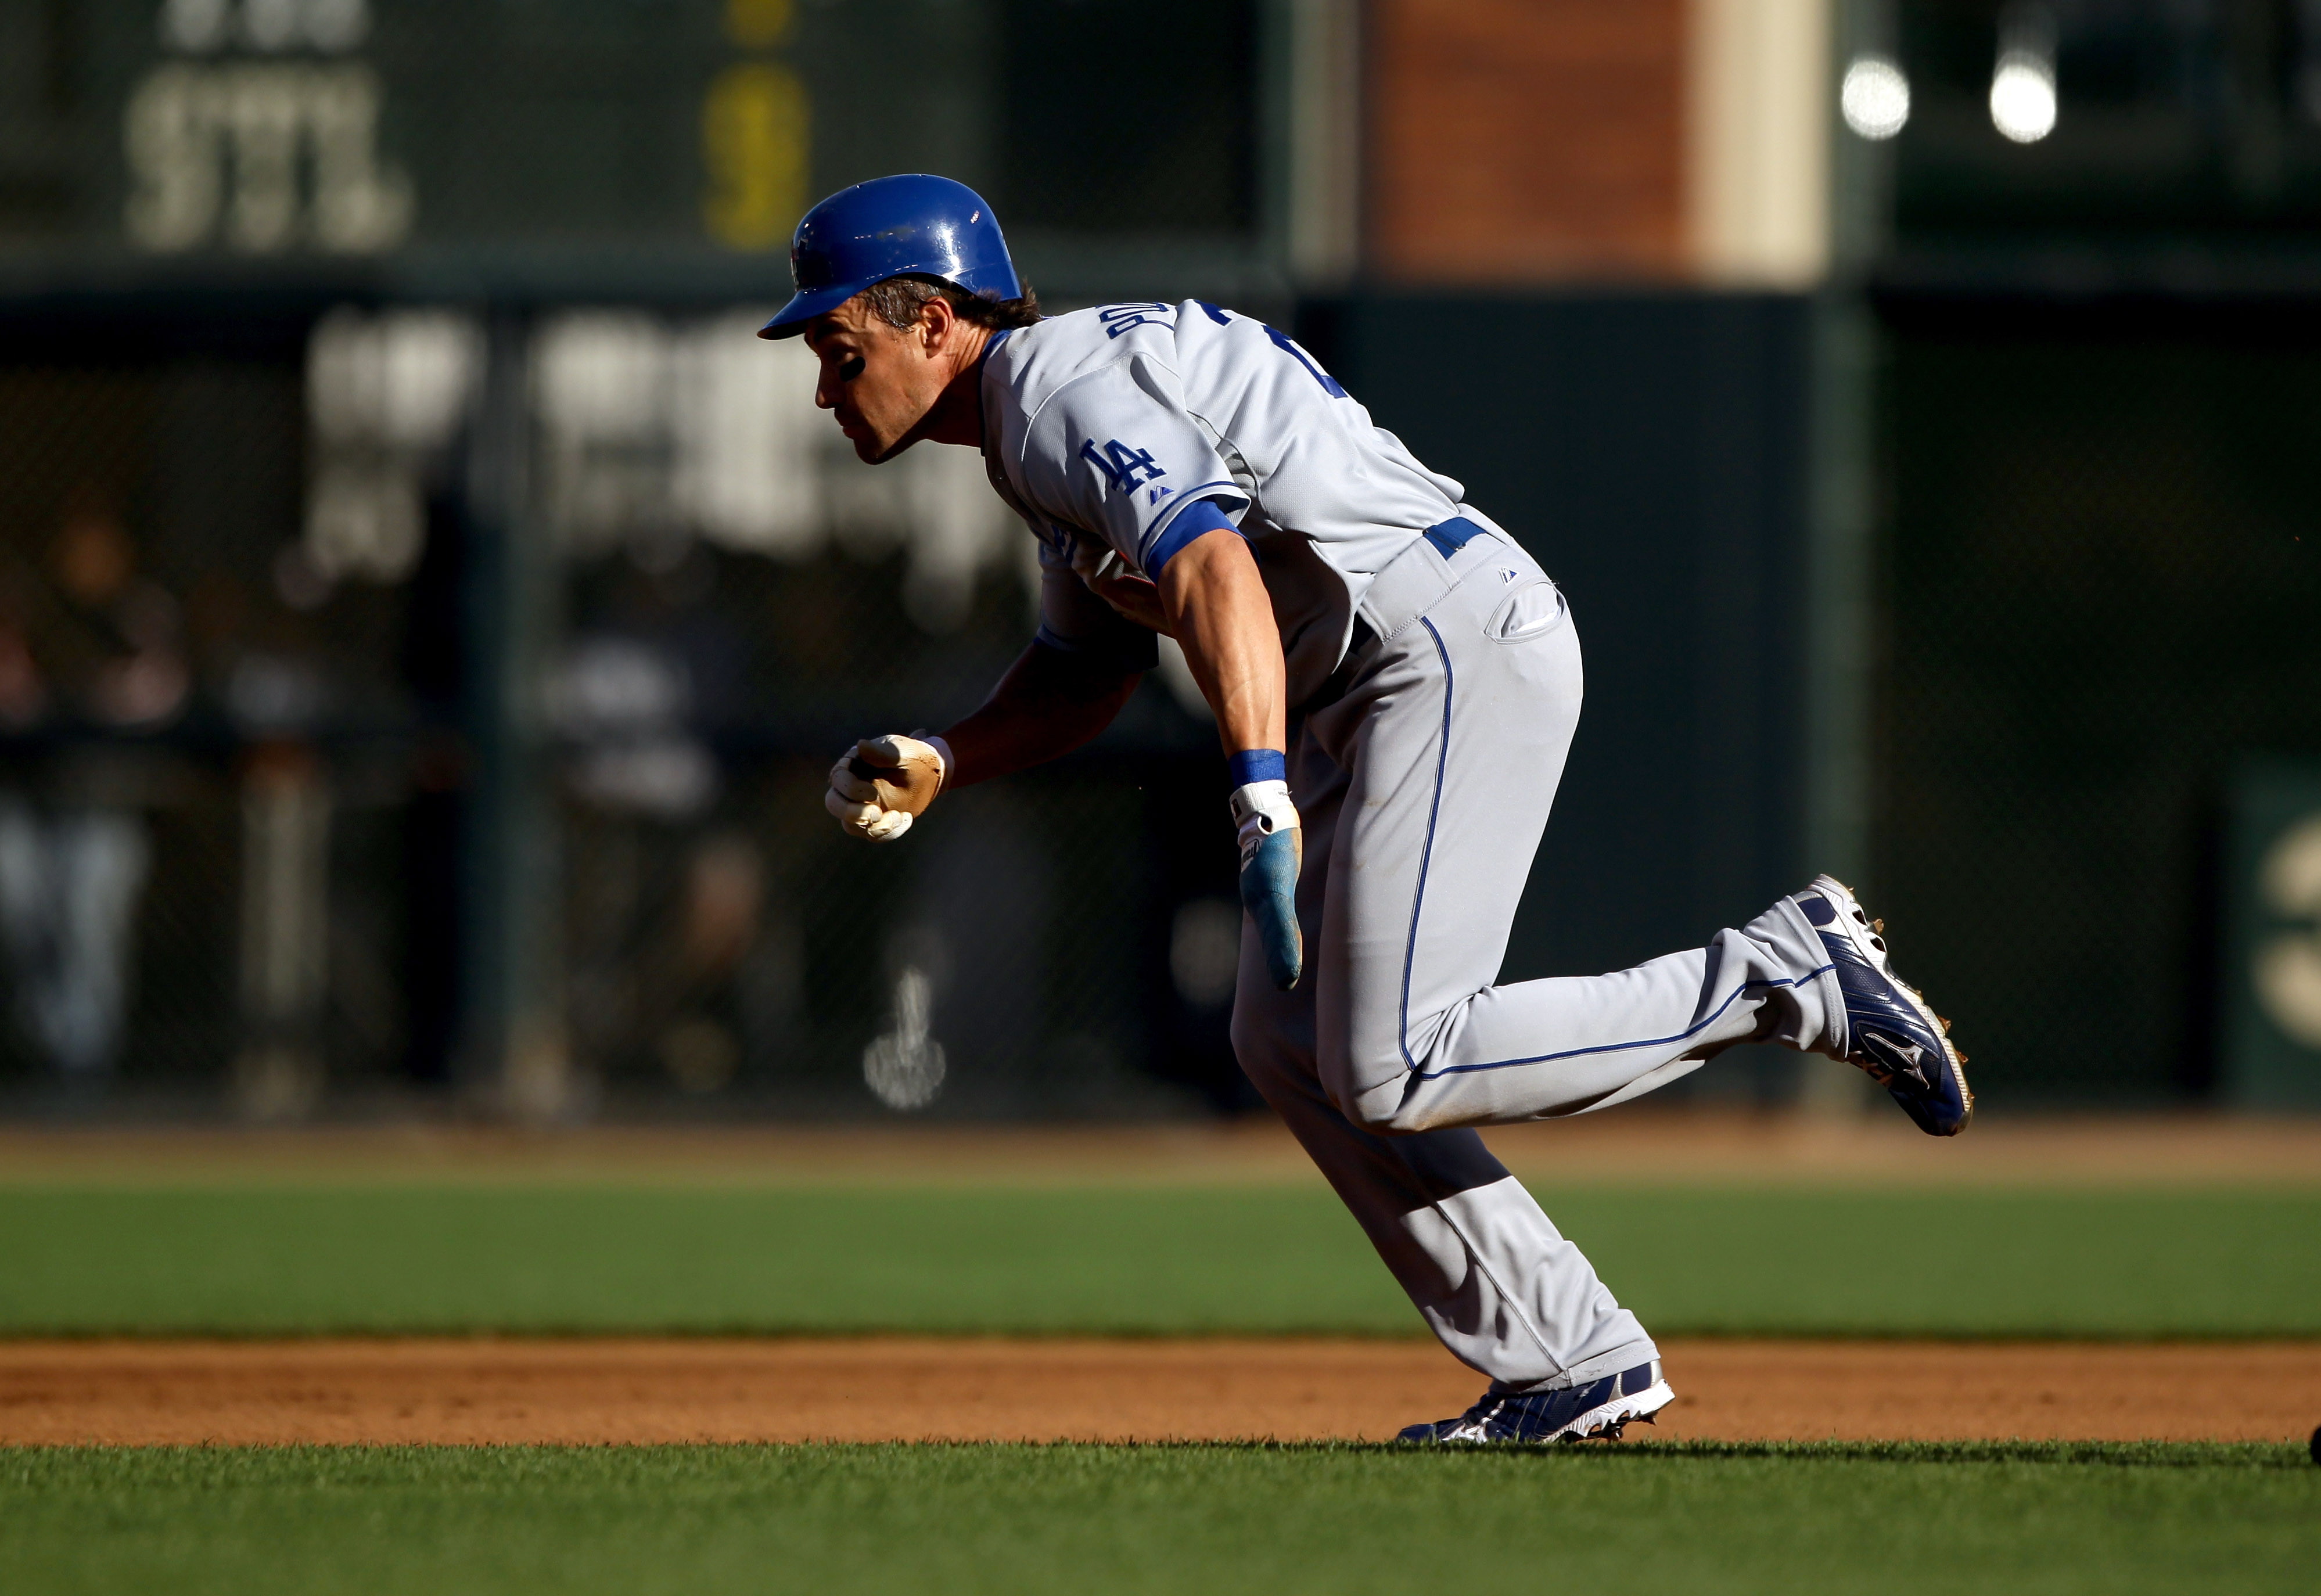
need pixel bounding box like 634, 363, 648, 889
0, 492, 191, 1081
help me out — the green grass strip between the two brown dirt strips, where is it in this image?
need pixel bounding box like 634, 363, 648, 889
0, 1183, 2321, 1336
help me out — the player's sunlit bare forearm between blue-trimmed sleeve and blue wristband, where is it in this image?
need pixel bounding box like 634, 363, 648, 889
1160, 527, 1288, 754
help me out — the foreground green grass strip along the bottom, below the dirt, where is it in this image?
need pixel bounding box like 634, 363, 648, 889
0, 1445, 2321, 1596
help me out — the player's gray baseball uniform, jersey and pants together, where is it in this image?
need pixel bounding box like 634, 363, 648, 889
961, 299, 1845, 1390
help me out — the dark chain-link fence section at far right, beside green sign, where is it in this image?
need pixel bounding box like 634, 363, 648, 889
1876, 301, 2321, 1106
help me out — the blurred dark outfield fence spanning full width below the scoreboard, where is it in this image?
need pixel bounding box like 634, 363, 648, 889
0, 294, 2321, 1116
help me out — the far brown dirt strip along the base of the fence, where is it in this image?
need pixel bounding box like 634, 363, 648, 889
13, 1104, 2321, 1188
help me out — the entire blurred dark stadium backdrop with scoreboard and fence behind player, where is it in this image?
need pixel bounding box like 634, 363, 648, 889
0, 0, 2321, 1120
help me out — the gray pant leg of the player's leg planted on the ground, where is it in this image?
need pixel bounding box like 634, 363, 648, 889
1233, 738, 1657, 1390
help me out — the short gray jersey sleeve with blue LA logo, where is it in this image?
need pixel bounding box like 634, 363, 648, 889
1021, 355, 1249, 578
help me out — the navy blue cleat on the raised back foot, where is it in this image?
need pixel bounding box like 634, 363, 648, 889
1790, 875, 1975, 1137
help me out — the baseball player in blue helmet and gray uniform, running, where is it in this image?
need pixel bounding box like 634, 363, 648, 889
759, 177, 1973, 1443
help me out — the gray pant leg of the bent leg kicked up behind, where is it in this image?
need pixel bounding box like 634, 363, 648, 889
1293, 538, 1843, 1132
